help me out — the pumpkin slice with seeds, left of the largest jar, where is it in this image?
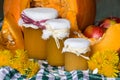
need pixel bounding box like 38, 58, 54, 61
1, 13, 24, 50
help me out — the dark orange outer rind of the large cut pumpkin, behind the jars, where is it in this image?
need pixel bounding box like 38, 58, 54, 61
77, 0, 96, 30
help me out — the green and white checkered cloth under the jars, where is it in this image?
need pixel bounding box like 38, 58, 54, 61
0, 61, 120, 80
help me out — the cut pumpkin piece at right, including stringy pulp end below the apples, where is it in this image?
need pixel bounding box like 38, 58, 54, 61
71, 24, 120, 54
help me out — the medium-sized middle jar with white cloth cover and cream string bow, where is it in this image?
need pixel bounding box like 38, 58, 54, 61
43, 19, 70, 66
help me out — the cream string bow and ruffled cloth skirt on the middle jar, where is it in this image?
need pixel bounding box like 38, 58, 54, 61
42, 25, 69, 49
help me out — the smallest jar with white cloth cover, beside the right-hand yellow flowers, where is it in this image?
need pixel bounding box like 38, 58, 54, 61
62, 38, 90, 71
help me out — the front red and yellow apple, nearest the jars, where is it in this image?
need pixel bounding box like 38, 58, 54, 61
83, 25, 104, 39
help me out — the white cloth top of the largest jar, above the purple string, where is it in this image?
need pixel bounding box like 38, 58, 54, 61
22, 7, 58, 21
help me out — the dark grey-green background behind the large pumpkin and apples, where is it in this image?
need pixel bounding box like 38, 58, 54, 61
0, 0, 120, 24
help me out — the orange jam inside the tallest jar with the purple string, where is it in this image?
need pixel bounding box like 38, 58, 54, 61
23, 28, 47, 59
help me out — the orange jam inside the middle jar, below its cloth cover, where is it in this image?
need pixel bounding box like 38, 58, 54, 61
47, 37, 64, 66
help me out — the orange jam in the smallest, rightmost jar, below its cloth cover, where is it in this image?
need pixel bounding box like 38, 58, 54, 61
63, 52, 88, 71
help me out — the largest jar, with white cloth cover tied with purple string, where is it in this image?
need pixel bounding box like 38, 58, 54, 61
19, 7, 58, 59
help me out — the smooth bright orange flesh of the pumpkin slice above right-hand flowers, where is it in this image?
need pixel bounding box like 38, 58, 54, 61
92, 24, 120, 53
